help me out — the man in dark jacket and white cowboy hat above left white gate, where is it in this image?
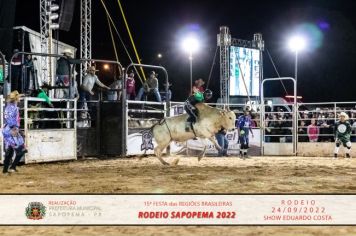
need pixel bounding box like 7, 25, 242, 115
56, 48, 81, 98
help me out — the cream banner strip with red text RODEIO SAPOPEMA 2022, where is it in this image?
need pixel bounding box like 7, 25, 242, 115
0, 195, 356, 225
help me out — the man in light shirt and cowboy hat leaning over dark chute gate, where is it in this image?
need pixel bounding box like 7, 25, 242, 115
78, 66, 110, 109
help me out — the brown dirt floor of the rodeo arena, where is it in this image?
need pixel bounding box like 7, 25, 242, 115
0, 157, 356, 235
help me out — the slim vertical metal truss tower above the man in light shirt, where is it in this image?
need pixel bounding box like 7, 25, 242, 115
80, 0, 91, 83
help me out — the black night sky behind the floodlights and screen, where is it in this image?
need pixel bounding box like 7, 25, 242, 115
15, 0, 356, 102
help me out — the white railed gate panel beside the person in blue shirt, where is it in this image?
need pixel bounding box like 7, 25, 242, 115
20, 97, 77, 163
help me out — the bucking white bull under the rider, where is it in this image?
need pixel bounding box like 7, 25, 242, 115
152, 103, 236, 165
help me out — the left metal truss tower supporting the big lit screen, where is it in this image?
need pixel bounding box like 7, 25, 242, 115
217, 26, 231, 104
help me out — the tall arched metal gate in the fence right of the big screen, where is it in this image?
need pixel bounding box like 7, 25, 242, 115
261, 77, 297, 156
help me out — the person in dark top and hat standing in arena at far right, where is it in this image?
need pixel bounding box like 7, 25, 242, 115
334, 112, 351, 158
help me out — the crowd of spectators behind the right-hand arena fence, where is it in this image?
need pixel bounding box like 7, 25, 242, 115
263, 103, 356, 142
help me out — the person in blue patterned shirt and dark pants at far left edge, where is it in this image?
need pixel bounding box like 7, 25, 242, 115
3, 90, 27, 174
